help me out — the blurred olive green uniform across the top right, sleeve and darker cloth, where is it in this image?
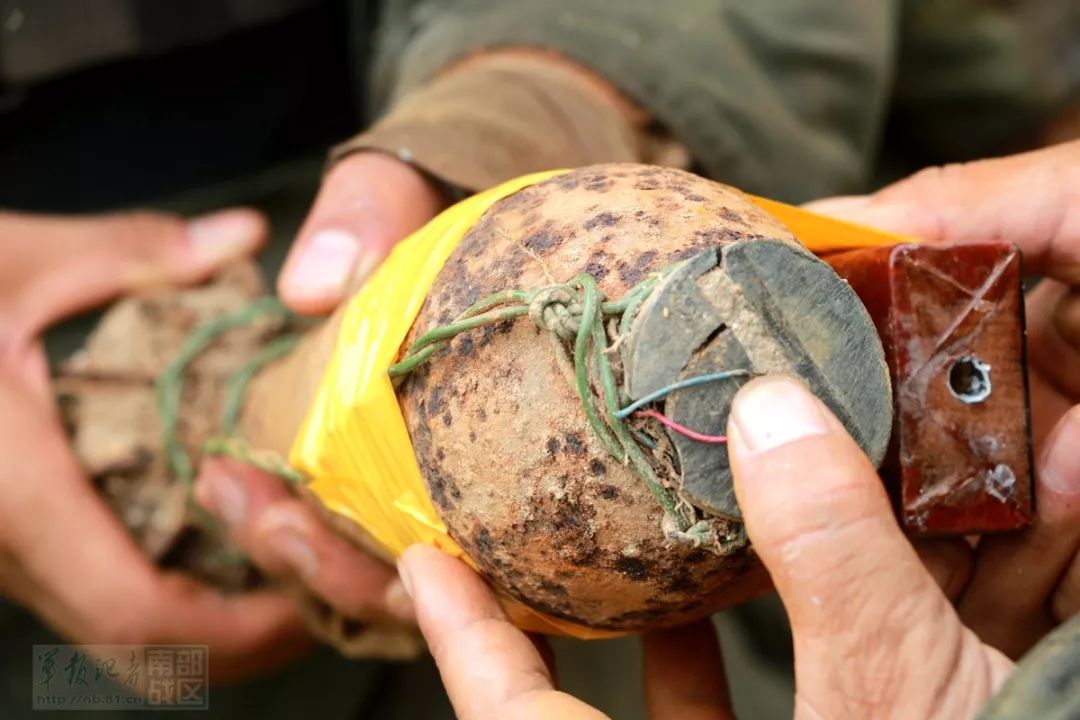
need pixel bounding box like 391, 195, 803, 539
372, 0, 1080, 202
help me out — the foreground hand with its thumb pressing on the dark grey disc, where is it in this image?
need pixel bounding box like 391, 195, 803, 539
399, 377, 1028, 720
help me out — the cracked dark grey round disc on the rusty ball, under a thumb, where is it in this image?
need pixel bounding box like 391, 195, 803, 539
625, 240, 892, 519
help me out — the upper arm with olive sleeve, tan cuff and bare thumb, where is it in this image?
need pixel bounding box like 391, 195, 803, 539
279, 0, 896, 313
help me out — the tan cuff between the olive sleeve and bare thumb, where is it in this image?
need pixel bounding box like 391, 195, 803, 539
330, 52, 685, 191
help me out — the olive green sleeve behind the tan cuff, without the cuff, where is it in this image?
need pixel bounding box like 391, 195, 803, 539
373, 0, 900, 202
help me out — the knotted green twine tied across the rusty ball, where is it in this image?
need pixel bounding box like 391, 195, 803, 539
389, 264, 689, 530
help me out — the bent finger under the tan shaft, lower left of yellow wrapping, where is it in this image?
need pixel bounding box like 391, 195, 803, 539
197, 460, 414, 622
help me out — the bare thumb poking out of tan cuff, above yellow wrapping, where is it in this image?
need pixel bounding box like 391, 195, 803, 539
278, 152, 445, 314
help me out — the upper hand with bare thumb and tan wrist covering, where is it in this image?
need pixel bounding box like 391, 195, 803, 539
278, 42, 639, 314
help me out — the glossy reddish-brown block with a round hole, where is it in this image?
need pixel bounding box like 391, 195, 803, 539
828, 243, 1032, 535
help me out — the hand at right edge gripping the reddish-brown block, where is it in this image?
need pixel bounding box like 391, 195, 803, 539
810, 141, 1080, 657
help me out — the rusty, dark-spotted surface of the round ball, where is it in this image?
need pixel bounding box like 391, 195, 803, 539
402, 164, 794, 630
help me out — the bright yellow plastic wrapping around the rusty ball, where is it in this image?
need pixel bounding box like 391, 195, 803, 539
289, 171, 910, 638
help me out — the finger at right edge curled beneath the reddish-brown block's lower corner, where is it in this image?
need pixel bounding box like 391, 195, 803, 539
959, 407, 1080, 657
